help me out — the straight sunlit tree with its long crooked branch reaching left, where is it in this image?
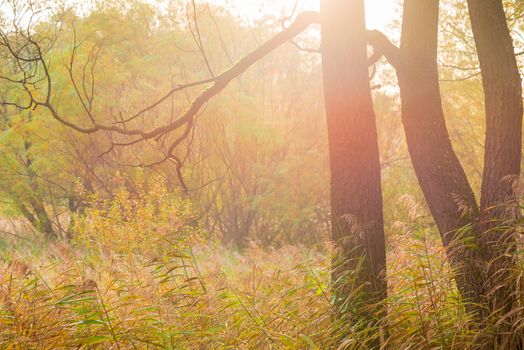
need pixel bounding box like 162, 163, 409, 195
2, 1, 386, 346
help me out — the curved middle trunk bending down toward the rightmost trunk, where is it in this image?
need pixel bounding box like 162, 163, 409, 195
396, 0, 482, 312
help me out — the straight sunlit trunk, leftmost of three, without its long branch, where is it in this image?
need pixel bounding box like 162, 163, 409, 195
321, 0, 387, 347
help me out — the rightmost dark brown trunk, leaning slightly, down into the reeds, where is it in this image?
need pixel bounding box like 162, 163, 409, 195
468, 0, 523, 348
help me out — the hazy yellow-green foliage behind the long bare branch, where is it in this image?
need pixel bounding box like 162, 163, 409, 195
0, 1, 334, 246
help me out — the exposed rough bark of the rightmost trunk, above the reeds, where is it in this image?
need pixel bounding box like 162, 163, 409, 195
468, 0, 523, 214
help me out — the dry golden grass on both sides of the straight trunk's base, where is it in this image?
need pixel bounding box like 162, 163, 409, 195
0, 238, 474, 349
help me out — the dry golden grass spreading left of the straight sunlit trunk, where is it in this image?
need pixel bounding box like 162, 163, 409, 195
0, 245, 330, 349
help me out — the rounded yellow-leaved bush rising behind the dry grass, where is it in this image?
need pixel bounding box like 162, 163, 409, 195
74, 177, 206, 257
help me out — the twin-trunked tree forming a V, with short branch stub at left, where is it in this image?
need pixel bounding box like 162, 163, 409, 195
368, 0, 522, 347
